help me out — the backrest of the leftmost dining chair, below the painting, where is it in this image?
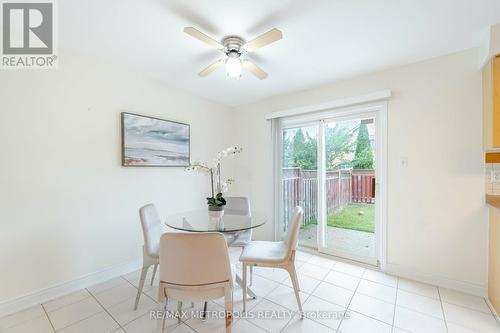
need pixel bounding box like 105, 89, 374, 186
139, 204, 162, 256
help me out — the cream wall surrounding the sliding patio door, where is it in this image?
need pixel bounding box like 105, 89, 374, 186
231, 50, 487, 292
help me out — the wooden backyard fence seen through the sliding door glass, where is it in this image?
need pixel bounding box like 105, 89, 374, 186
282, 168, 375, 224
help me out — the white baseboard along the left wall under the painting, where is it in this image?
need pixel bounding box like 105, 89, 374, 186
0, 258, 142, 317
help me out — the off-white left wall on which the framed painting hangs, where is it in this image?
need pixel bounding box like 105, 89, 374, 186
0, 50, 232, 303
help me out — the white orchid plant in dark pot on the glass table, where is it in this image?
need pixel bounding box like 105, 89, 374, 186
186, 146, 243, 210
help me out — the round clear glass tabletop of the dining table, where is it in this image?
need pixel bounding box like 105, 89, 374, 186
165, 209, 267, 232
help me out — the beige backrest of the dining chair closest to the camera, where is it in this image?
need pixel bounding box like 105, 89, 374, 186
160, 232, 232, 286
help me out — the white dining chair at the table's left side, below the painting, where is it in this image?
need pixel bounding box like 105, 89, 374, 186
134, 204, 162, 310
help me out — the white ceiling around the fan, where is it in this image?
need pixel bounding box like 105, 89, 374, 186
58, 0, 500, 106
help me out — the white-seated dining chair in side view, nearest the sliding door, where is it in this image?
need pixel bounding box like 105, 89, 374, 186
240, 206, 304, 318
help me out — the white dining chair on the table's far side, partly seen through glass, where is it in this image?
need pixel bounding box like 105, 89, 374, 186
224, 197, 253, 285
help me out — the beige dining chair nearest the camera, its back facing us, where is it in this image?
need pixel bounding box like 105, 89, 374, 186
158, 232, 233, 333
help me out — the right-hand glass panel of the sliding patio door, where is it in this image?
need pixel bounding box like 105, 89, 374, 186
318, 116, 377, 263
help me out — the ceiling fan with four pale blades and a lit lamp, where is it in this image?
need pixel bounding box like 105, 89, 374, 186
184, 27, 283, 80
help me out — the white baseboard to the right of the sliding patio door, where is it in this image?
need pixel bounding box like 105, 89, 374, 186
384, 263, 488, 298
